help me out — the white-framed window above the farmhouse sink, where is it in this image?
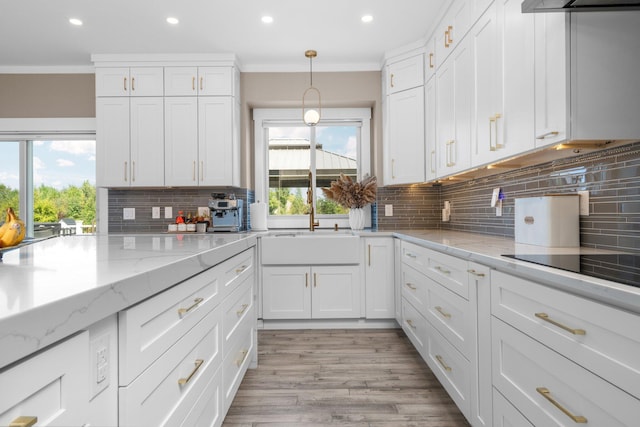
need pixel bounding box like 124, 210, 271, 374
254, 109, 371, 228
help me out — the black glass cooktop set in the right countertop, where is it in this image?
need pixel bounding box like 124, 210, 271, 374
503, 254, 640, 288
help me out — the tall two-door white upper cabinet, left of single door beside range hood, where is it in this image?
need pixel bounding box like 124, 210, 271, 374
470, 0, 534, 166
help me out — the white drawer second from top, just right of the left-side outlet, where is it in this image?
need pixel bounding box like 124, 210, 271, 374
119, 306, 222, 426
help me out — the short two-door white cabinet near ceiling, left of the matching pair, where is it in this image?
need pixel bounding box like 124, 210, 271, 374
96, 67, 163, 97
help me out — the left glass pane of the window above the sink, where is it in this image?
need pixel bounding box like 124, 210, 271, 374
268, 126, 311, 215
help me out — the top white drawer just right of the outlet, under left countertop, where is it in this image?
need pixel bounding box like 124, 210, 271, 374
118, 260, 225, 385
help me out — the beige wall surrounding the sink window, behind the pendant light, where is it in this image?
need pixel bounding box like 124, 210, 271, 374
241, 71, 382, 188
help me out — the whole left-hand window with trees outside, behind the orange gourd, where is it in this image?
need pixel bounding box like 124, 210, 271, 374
0, 139, 96, 237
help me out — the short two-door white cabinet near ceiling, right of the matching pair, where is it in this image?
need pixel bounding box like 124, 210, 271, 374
164, 67, 234, 96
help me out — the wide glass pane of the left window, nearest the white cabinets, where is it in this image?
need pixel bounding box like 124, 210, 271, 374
33, 141, 96, 234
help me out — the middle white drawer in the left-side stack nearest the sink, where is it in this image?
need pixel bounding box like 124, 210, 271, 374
222, 276, 256, 357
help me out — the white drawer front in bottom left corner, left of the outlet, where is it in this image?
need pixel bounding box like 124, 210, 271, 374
0, 332, 90, 426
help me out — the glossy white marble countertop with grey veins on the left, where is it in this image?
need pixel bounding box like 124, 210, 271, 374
0, 233, 257, 368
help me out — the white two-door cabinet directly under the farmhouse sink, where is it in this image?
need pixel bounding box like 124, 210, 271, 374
262, 265, 362, 319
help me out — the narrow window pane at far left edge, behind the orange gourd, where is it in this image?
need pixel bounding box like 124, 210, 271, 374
0, 141, 20, 219
